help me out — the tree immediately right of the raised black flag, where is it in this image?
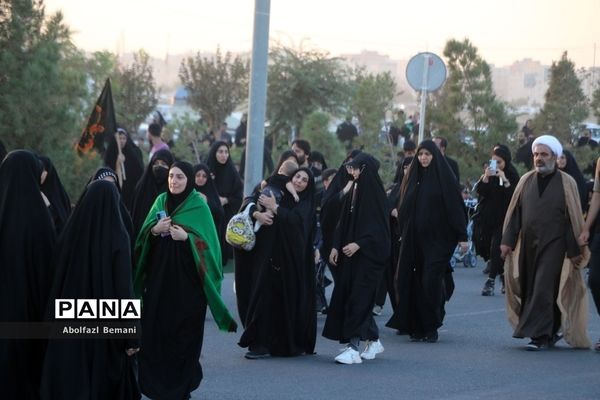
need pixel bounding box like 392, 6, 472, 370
115, 50, 158, 132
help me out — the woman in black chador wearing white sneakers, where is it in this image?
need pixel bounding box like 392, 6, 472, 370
323, 153, 390, 364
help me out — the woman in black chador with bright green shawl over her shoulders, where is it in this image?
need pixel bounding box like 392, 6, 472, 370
134, 162, 237, 399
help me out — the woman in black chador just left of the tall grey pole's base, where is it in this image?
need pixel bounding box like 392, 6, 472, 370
206, 141, 244, 265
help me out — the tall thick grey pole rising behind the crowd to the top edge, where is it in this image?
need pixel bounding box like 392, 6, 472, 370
244, 0, 271, 196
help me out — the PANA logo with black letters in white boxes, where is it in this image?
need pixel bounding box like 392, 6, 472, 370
54, 299, 142, 319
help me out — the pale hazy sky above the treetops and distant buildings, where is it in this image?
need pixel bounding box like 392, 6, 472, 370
45, 0, 600, 67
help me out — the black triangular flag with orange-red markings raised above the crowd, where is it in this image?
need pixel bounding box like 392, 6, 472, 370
77, 79, 117, 154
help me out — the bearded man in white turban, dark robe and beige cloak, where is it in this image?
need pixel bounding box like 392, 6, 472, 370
500, 135, 590, 351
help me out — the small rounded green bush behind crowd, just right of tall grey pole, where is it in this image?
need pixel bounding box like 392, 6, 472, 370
302, 111, 346, 168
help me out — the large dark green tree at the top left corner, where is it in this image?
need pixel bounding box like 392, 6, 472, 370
0, 0, 98, 198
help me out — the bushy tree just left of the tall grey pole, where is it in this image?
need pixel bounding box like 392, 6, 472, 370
179, 48, 250, 132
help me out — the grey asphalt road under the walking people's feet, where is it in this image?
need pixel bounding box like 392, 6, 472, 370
148, 262, 600, 400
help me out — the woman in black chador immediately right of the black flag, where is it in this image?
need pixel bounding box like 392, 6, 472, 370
104, 128, 144, 211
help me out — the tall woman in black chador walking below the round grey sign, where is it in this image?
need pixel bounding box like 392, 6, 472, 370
387, 140, 467, 342
